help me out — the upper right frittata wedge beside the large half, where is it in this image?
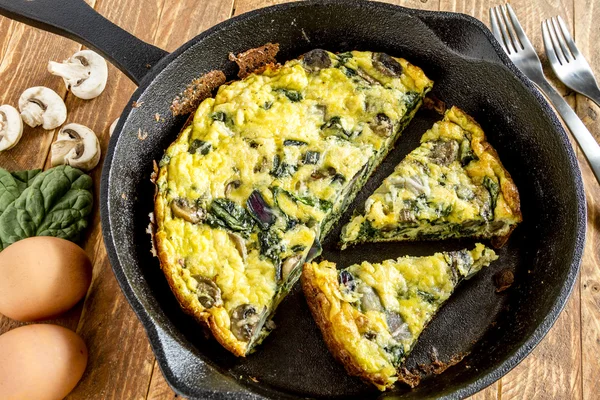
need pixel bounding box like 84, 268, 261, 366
341, 107, 522, 247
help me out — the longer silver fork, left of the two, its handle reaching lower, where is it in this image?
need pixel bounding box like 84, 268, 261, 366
490, 3, 600, 183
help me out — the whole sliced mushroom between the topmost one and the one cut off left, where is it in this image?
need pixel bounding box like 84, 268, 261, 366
19, 86, 67, 129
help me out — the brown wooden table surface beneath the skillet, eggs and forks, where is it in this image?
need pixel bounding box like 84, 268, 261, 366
0, 0, 600, 400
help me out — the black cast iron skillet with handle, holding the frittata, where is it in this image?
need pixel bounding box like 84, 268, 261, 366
0, 0, 586, 399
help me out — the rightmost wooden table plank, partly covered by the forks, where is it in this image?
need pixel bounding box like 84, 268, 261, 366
574, 0, 600, 400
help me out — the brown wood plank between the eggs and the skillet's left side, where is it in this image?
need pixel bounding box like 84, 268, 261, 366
47, 0, 164, 399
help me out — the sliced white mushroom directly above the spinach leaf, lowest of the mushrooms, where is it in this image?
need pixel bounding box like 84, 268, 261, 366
51, 124, 100, 171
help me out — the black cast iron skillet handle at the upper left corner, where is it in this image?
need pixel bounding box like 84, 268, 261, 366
0, 0, 168, 85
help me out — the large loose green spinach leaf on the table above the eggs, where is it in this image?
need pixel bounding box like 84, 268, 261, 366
0, 165, 93, 250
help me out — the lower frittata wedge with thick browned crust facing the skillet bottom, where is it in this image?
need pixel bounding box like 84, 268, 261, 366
302, 244, 498, 390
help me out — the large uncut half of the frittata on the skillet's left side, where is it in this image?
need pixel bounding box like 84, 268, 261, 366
154, 50, 432, 356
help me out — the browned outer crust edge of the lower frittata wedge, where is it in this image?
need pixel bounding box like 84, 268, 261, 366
301, 263, 393, 388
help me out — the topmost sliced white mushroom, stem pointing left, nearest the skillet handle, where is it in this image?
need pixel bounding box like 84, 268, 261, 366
48, 50, 108, 100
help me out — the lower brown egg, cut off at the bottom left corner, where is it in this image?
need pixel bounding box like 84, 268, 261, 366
0, 324, 87, 400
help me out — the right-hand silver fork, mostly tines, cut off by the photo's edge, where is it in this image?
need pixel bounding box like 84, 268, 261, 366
542, 16, 600, 106
